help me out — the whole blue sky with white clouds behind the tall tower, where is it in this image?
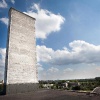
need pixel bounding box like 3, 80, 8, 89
0, 0, 100, 80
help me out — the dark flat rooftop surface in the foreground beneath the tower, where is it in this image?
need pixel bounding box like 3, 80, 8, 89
0, 89, 100, 100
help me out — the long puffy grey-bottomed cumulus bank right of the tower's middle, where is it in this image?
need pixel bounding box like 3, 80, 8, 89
37, 40, 100, 65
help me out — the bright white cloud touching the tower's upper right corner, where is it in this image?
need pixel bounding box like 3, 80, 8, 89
24, 4, 65, 39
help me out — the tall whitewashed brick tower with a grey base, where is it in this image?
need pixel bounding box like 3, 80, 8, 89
4, 8, 38, 94
